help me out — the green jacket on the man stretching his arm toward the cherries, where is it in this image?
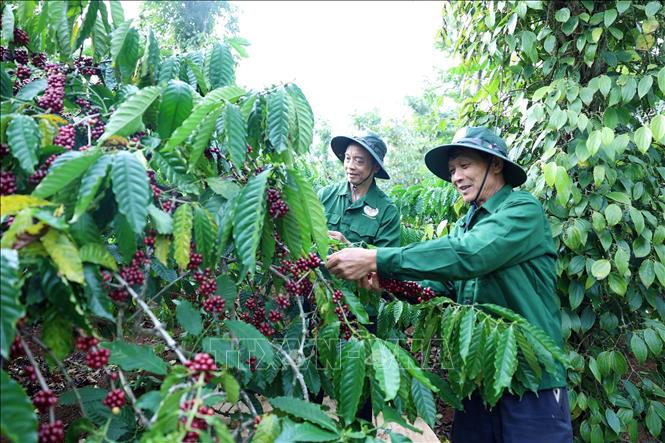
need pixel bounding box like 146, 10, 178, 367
376, 185, 566, 389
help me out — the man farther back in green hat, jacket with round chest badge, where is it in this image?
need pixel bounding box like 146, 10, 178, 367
319, 135, 400, 250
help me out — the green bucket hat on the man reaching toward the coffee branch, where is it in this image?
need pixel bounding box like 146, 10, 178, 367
425, 126, 526, 187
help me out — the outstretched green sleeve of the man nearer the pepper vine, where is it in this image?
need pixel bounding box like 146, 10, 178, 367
376, 199, 545, 281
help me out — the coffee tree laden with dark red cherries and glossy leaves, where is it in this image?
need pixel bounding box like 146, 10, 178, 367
0, 1, 565, 442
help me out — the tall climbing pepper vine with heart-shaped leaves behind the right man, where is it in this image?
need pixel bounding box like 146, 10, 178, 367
445, 1, 665, 442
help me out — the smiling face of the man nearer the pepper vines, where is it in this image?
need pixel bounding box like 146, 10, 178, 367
448, 149, 505, 203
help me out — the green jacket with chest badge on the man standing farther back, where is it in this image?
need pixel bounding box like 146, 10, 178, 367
319, 181, 400, 250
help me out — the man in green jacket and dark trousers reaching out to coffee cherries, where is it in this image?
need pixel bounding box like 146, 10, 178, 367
326, 127, 572, 443
